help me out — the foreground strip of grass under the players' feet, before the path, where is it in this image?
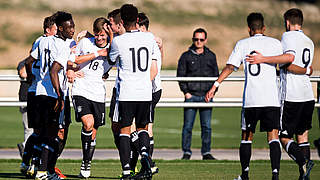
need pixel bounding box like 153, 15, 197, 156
0, 160, 320, 180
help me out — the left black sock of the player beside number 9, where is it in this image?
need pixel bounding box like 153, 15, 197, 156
239, 141, 252, 179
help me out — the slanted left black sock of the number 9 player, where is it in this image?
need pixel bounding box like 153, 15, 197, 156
286, 140, 306, 167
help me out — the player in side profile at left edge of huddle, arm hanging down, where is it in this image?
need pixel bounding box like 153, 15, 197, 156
27, 11, 74, 179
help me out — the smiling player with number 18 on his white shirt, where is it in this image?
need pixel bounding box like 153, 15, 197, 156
72, 17, 113, 178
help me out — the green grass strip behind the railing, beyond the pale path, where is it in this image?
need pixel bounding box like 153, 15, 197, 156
0, 107, 320, 148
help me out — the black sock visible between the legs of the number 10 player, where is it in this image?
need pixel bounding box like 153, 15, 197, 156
130, 131, 139, 171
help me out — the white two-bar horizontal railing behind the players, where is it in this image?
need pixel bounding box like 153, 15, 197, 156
0, 75, 320, 107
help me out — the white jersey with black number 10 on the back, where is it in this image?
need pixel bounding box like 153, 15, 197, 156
109, 31, 160, 101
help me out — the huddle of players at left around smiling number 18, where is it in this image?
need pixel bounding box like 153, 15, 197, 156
20, 4, 162, 180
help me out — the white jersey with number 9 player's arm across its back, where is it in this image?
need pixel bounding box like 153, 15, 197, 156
227, 34, 282, 108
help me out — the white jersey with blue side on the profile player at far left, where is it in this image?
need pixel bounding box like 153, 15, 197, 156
31, 36, 71, 98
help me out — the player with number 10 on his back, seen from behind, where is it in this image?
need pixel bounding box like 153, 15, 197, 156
109, 4, 159, 179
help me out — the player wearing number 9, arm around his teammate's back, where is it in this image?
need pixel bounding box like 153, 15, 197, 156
248, 8, 315, 179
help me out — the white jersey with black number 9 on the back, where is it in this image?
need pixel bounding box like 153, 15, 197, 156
280, 31, 314, 102
